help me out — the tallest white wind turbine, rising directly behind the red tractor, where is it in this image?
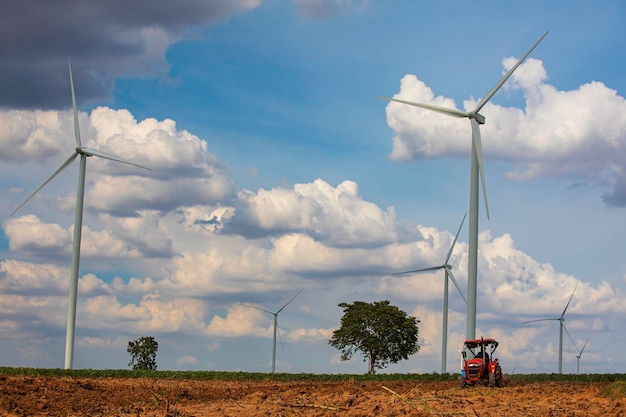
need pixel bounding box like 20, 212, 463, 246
377, 32, 548, 339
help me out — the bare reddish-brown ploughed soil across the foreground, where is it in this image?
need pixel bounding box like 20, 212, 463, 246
0, 376, 626, 417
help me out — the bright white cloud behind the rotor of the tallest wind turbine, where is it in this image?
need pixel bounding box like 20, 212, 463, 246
380, 58, 626, 205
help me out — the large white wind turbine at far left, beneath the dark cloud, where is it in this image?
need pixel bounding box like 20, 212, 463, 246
11, 63, 150, 369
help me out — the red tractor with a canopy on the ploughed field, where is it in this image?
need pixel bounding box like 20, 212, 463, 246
459, 337, 504, 388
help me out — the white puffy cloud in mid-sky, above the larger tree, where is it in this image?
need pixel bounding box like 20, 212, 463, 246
224, 179, 397, 247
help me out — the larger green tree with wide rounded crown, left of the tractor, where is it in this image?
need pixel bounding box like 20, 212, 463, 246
328, 300, 420, 374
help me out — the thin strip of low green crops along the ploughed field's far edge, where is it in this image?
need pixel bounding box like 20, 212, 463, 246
0, 367, 626, 382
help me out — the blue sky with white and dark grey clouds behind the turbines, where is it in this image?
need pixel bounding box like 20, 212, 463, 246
0, 0, 626, 373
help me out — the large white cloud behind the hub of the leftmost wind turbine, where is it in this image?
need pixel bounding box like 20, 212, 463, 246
0, 107, 235, 216
